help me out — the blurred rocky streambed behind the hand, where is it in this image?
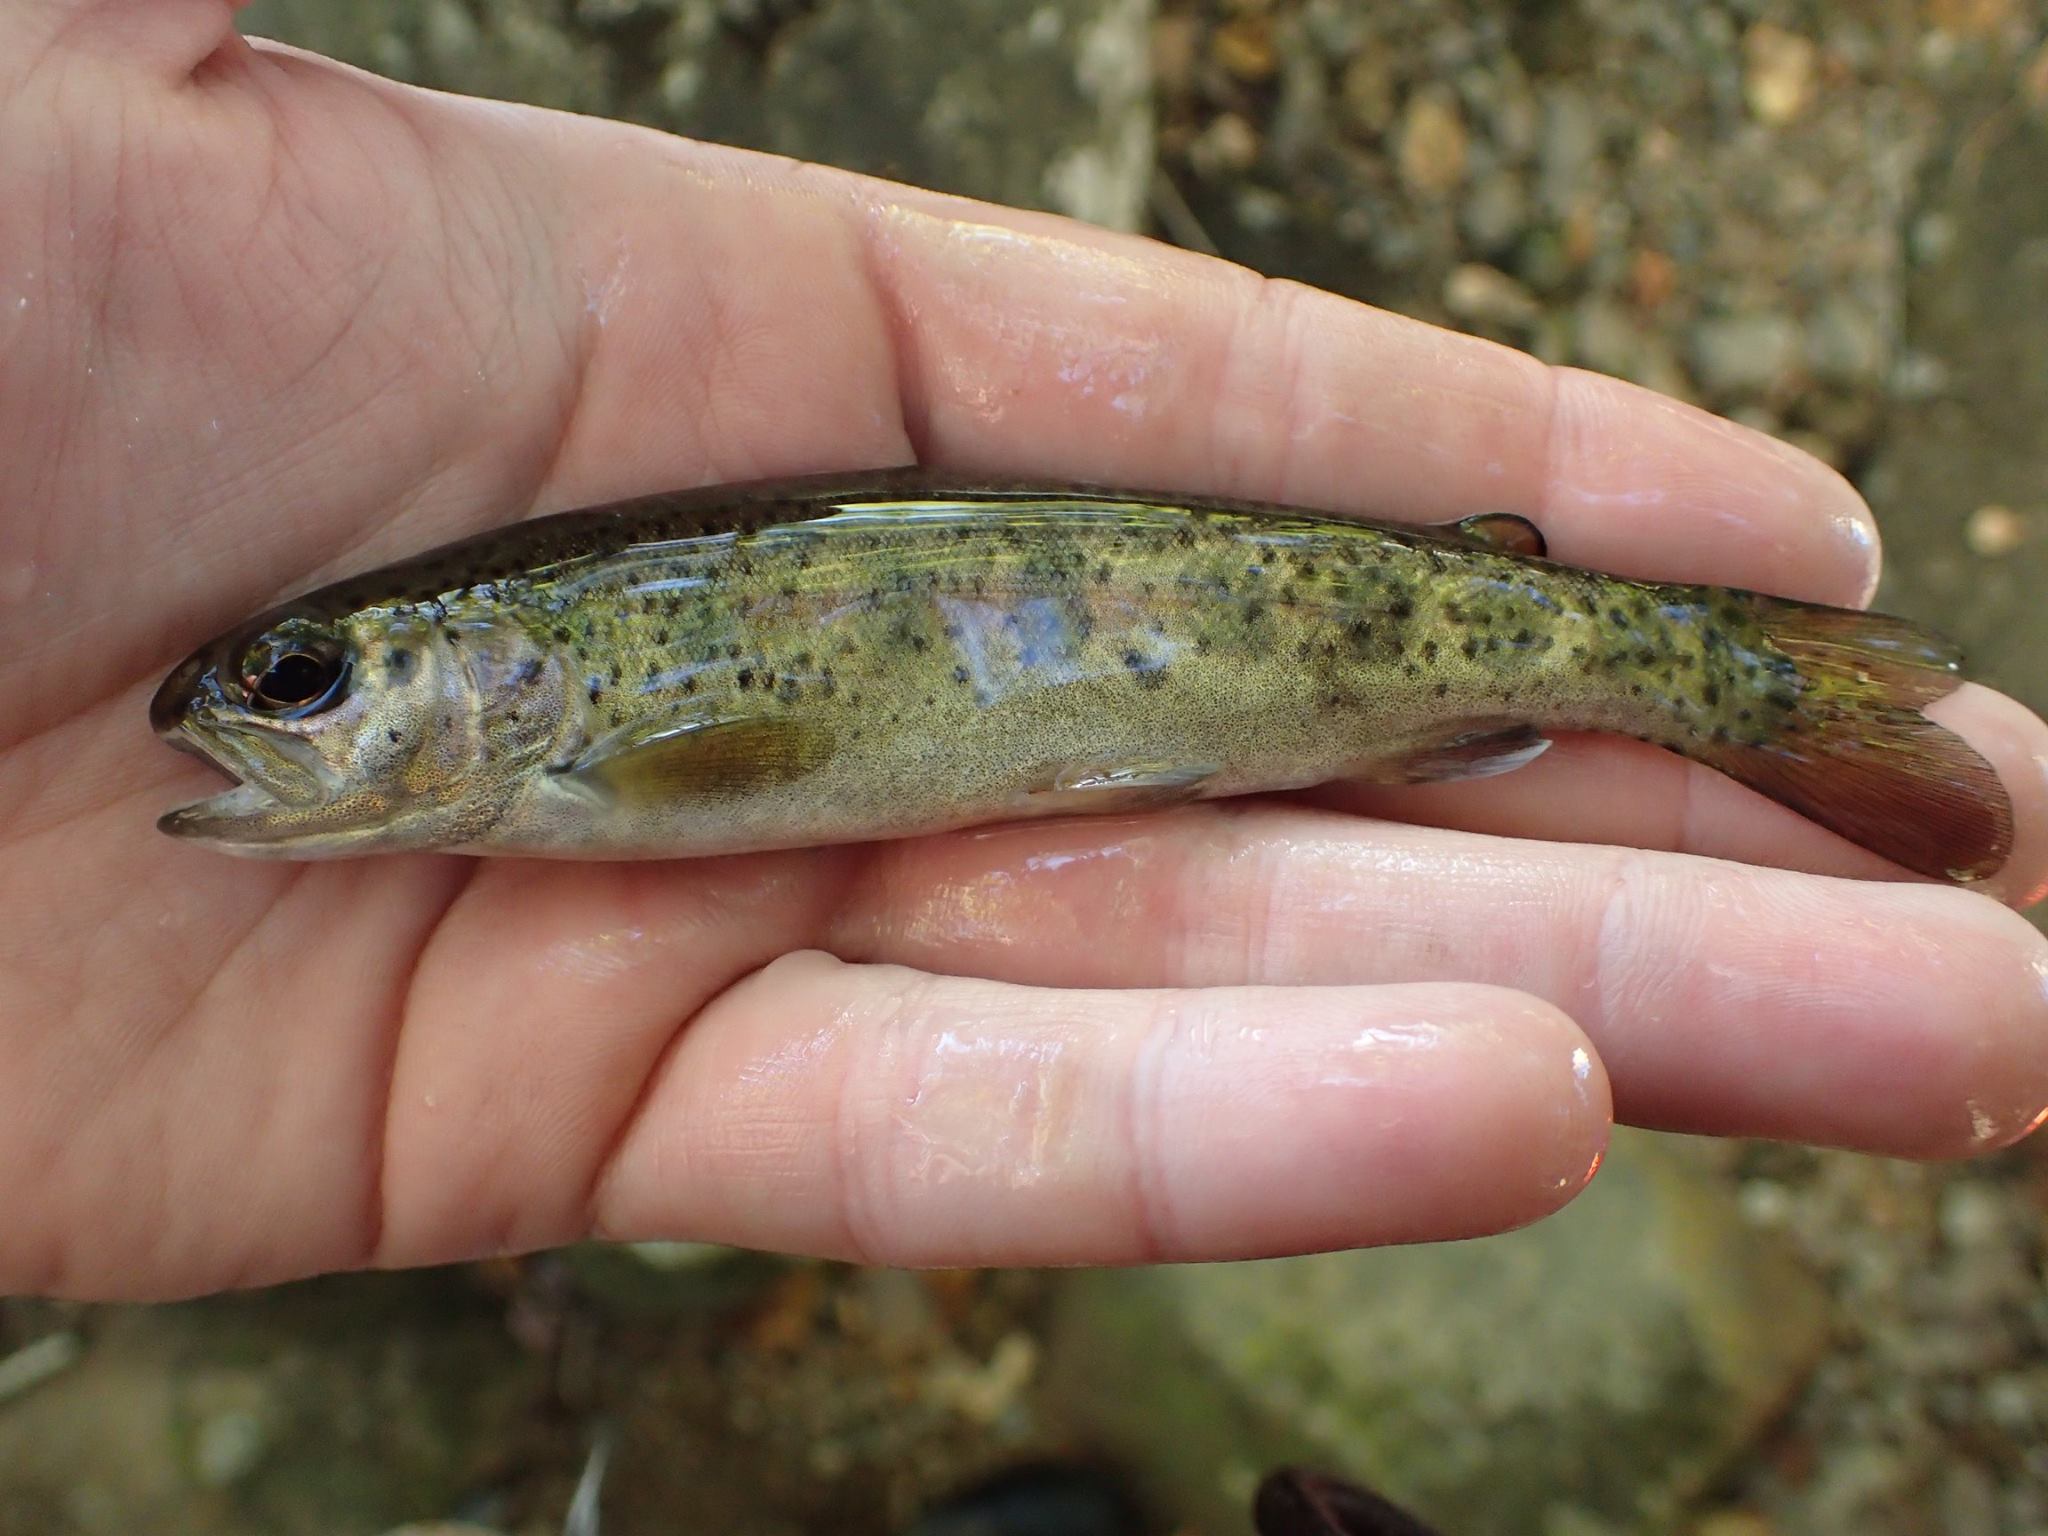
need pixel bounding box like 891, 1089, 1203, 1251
12, 0, 2048, 1536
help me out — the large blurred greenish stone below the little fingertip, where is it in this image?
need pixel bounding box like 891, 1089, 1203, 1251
1047, 1133, 1829, 1536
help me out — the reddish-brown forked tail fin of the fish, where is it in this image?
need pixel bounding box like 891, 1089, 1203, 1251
1702, 600, 2013, 881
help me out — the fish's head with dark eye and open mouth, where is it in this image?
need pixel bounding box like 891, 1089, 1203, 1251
150, 602, 580, 858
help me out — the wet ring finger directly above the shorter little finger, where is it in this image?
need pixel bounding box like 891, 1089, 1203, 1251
827, 805, 2048, 1157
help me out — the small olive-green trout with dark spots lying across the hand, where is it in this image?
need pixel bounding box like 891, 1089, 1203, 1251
150, 469, 2013, 883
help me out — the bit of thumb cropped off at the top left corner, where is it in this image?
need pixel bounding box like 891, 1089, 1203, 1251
14, 0, 246, 94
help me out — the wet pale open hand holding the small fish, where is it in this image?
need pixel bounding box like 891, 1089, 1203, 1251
0, 0, 2048, 1296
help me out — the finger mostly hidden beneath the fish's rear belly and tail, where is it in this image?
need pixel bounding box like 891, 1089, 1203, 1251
1311, 684, 2048, 905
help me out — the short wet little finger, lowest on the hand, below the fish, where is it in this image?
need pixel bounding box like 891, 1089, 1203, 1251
596, 954, 1608, 1266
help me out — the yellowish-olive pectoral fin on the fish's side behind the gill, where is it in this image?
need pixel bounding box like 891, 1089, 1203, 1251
559, 715, 831, 803
